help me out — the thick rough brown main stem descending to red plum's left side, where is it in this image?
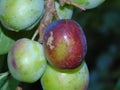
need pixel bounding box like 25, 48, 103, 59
38, 0, 59, 43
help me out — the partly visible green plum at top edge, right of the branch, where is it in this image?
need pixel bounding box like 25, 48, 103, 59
71, 0, 105, 9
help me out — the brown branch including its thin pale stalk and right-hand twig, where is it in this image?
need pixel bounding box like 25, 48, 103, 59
32, 0, 85, 43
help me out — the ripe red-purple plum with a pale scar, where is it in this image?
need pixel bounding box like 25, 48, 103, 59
44, 19, 87, 69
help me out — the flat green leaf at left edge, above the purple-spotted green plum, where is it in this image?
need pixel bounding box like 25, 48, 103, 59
0, 25, 15, 55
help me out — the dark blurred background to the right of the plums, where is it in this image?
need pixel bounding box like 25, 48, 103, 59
73, 0, 120, 90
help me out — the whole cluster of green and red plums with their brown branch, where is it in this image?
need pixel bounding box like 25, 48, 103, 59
0, 0, 104, 90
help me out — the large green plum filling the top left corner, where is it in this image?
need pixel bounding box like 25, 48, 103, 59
0, 0, 44, 31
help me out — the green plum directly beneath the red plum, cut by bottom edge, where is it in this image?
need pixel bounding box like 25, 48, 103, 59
41, 62, 89, 90
